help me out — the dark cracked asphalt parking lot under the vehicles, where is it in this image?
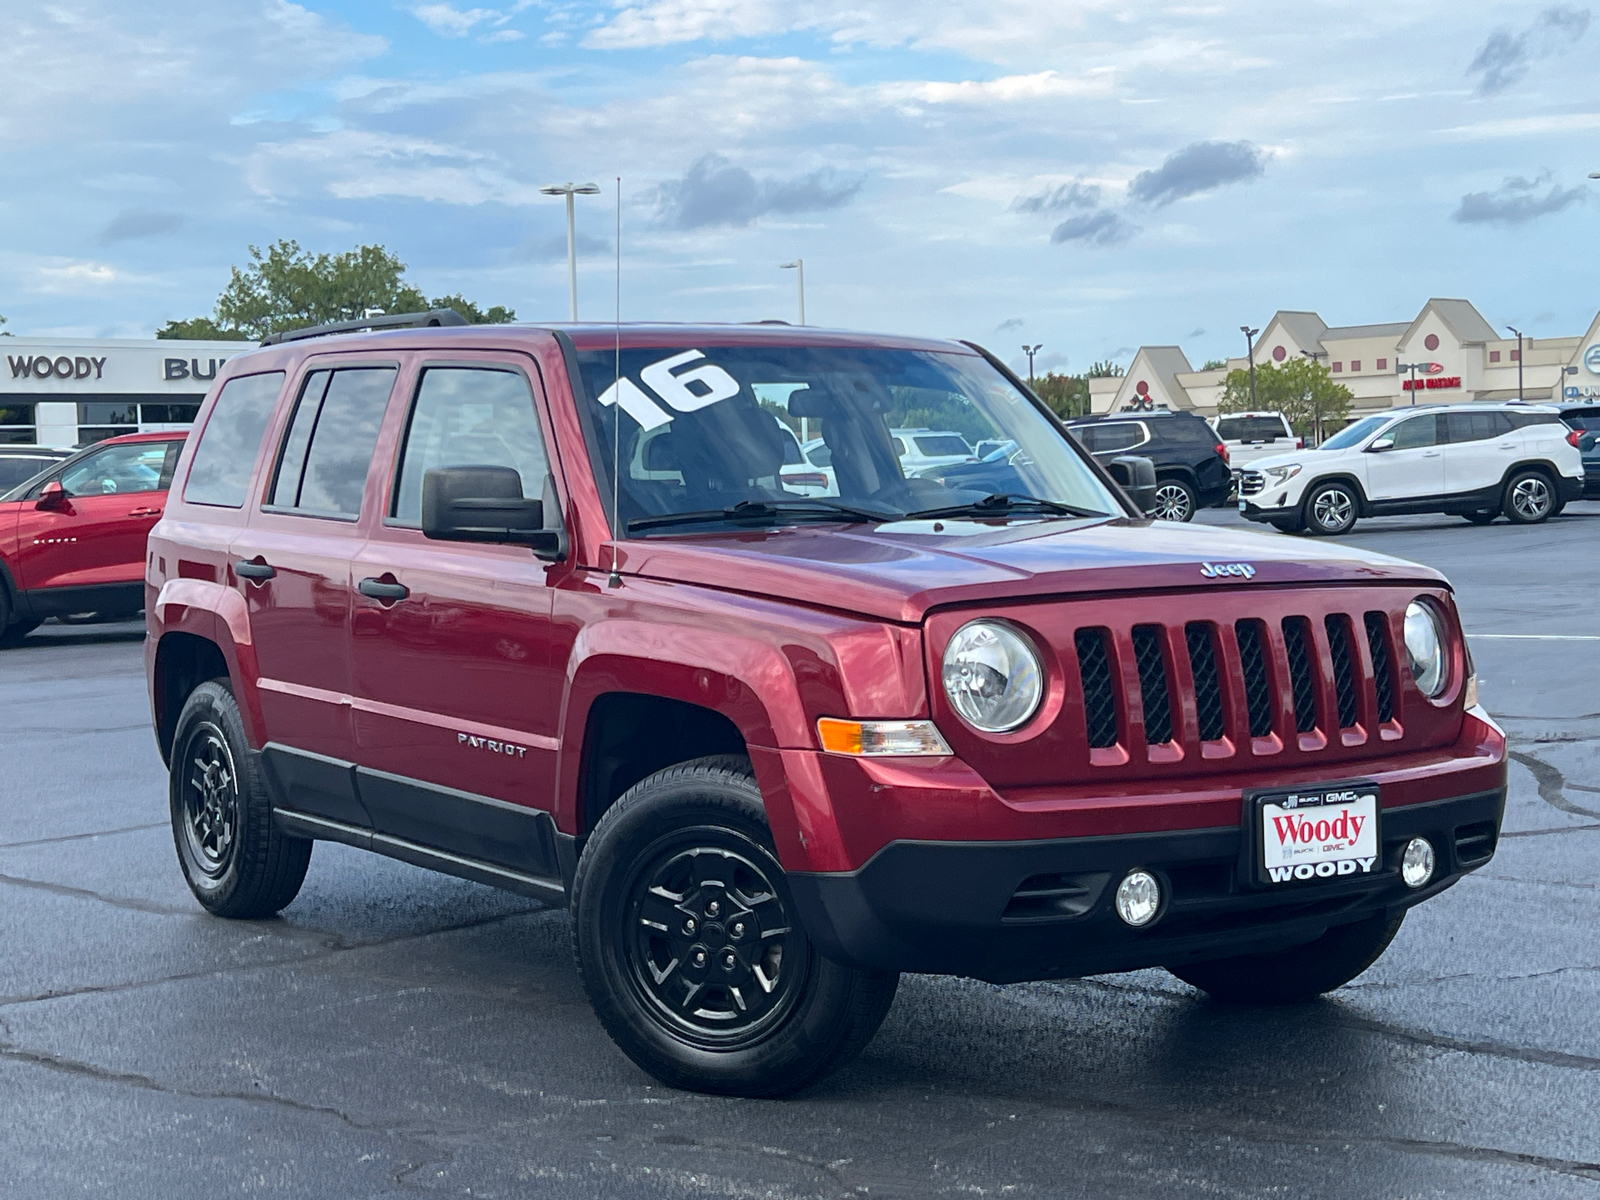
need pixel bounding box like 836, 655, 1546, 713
0, 504, 1600, 1198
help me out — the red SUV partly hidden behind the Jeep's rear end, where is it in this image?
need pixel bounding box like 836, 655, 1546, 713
0, 434, 184, 645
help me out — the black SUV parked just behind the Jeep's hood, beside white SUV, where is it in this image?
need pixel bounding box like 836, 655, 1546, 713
1064, 408, 1232, 522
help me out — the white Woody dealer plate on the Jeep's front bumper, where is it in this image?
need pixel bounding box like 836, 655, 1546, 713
1254, 782, 1382, 885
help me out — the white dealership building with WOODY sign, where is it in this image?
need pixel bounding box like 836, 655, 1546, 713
0, 338, 253, 448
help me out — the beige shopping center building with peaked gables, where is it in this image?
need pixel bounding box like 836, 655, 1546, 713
1090, 299, 1600, 416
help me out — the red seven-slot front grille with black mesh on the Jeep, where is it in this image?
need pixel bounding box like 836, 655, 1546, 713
1072, 594, 1420, 764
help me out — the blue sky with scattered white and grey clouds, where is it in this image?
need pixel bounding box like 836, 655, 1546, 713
0, 0, 1600, 371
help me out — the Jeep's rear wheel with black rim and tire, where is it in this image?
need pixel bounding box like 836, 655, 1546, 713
168, 680, 312, 920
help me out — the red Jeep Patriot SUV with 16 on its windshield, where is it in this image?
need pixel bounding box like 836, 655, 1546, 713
146, 314, 1506, 1096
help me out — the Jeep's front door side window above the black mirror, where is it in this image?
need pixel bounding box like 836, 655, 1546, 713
389, 366, 550, 525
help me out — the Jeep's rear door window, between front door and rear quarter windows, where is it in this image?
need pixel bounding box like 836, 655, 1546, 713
267, 366, 395, 520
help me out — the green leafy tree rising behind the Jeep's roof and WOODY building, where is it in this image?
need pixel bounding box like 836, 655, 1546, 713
162, 238, 517, 339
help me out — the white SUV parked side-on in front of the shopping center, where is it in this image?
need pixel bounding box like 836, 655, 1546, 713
1238, 403, 1584, 534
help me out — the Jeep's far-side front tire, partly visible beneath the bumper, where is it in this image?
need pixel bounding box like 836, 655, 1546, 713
1166, 914, 1405, 1005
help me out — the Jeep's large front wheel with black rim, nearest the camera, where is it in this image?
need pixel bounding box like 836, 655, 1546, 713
573, 755, 899, 1096
